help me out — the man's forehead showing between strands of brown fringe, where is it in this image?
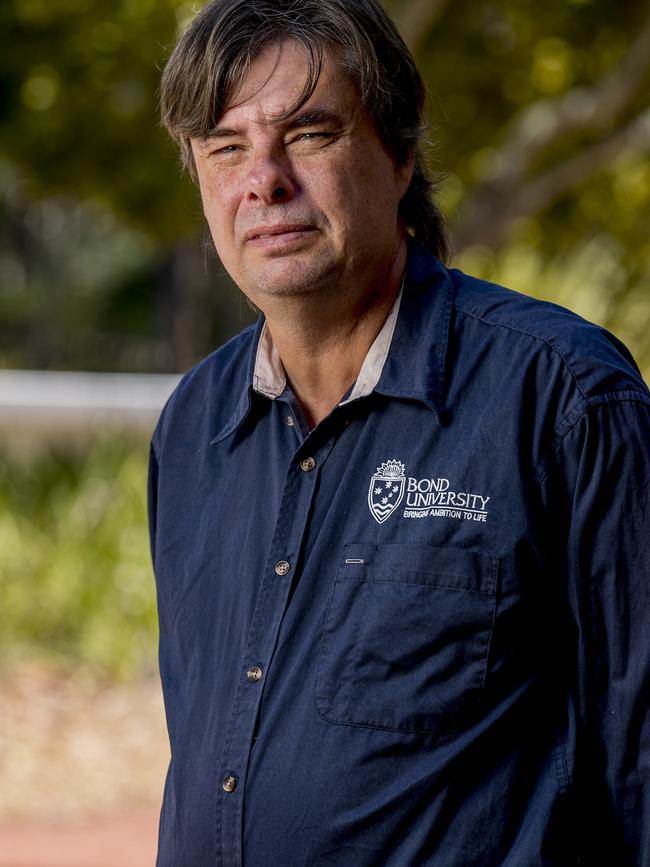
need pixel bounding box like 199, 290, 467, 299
224, 40, 358, 120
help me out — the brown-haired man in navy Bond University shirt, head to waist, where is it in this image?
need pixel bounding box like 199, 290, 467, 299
150, 0, 650, 867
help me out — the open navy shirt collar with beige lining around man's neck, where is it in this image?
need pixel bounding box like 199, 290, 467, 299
212, 244, 453, 443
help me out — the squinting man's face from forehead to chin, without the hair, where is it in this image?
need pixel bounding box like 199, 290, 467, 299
192, 41, 412, 310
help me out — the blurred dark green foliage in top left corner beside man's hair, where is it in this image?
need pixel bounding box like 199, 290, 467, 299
0, 0, 197, 245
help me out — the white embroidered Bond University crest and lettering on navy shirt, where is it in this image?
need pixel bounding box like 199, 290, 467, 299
368, 460, 490, 524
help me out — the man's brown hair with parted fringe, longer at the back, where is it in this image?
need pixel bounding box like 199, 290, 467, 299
160, 0, 448, 260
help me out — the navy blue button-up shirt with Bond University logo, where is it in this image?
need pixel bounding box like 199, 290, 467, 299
150, 248, 650, 867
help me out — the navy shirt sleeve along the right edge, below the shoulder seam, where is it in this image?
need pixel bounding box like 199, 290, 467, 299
546, 395, 650, 867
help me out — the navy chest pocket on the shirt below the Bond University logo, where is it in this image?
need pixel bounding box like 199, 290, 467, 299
315, 545, 499, 735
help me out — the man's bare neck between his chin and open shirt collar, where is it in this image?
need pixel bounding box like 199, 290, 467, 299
264, 240, 406, 427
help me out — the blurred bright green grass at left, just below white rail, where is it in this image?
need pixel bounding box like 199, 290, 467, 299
0, 439, 157, 679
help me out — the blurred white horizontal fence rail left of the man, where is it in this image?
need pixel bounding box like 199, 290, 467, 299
0, 370, 180, 436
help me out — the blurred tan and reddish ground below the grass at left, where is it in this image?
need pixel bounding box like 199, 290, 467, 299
0, 666, 169, 867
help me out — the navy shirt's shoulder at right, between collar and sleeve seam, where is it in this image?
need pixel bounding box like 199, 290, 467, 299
449, 269, 650, 405
